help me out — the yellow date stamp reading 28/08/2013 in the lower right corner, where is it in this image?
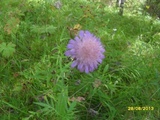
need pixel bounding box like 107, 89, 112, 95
128, 106, 154, 111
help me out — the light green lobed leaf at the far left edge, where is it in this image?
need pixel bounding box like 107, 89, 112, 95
0, 42, 16, 58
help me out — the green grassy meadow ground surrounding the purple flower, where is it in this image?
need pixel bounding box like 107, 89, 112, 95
0, 0, 160, 120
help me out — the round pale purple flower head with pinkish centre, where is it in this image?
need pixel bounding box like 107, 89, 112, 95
65, 31, 105, 73
